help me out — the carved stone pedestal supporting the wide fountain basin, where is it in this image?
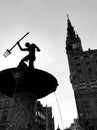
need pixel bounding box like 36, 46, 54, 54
9, 92, 37, 130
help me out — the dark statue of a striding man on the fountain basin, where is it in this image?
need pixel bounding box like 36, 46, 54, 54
17, 42, 40, 68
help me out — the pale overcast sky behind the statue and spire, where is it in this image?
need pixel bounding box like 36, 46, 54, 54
0, 0, 97, 128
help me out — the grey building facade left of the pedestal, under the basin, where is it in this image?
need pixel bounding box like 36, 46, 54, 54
0, 93, 15, 130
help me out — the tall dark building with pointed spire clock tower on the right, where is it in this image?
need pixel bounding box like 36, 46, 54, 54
66, 18, 97, 130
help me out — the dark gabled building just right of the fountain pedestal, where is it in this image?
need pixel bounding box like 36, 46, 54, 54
35, 101, 55, 130
